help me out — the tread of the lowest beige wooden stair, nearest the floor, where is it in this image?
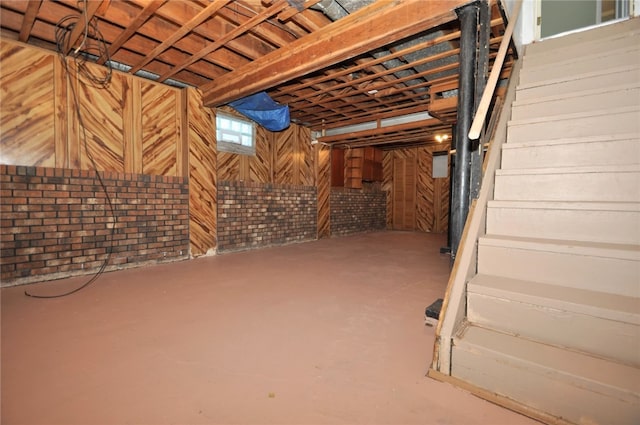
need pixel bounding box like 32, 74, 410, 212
454, 324, 640, 401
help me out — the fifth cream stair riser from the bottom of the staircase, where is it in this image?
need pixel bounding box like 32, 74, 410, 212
494, 172, 640, 202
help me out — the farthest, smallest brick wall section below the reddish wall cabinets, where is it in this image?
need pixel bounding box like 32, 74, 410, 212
330, 188, 387, 236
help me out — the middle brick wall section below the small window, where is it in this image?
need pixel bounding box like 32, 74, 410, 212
218, 181, 317, 252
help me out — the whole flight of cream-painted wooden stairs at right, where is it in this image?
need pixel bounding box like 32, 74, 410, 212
436, 19, 640, 424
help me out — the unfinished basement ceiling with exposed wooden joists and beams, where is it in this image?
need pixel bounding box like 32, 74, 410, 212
0, 0, 511, 148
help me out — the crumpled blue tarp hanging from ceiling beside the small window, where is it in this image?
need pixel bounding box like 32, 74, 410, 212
229, 92, 289, 131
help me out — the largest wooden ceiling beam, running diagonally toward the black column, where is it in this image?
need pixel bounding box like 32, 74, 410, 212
201, 0, 469, 106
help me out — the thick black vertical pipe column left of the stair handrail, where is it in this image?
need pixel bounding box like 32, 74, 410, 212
450, 3, 479, 258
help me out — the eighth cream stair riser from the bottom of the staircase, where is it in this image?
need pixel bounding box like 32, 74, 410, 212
511, 87, 640, 120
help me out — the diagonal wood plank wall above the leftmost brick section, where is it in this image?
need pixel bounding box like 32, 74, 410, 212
0, 39, 188, 177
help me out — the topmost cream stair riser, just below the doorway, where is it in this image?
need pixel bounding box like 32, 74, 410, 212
525, 19, 639, 56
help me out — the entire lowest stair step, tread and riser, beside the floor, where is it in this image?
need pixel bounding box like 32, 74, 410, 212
451, 326, 640, 424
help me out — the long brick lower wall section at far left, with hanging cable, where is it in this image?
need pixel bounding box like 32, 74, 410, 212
0, 165, 189, 285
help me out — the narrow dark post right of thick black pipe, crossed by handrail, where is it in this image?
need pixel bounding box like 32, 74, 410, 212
469, 0, 491, 203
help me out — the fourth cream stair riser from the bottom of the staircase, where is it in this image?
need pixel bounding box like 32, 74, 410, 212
487, 200, 640, 245
